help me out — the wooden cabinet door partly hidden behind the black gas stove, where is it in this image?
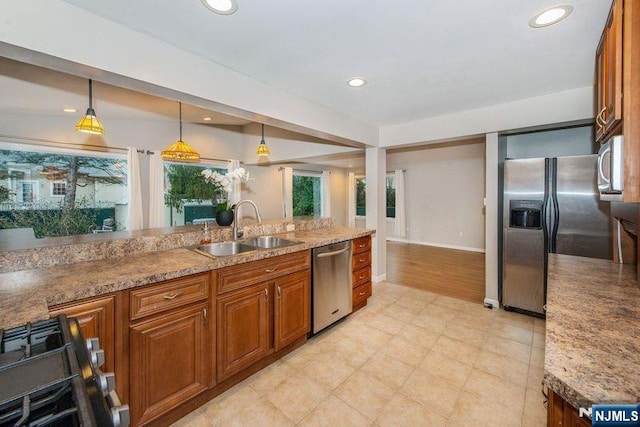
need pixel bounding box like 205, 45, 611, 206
49, 295, 115, 372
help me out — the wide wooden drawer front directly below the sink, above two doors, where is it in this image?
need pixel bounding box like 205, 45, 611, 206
213, 250, 311, 295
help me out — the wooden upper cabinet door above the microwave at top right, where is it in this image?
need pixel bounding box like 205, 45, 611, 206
595, 0, 623, 141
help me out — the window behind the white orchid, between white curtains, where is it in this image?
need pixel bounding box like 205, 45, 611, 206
164, 162, 227, 226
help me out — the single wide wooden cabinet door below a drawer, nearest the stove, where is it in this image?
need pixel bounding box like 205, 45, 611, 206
130, 304, 211, 425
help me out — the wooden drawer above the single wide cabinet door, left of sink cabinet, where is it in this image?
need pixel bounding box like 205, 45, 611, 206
130, 273, 209, 320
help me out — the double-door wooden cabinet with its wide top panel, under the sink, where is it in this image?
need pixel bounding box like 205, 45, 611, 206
214, 251, 311, 381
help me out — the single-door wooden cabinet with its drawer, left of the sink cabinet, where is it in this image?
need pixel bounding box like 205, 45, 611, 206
128, 273, 215, 425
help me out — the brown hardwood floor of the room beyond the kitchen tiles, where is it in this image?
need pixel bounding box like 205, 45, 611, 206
387, 242, 484, 303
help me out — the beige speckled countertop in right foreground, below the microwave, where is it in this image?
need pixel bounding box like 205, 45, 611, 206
544, 254, 640, 408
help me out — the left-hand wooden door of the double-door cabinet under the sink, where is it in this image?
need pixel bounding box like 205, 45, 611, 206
217, 283, 273, 381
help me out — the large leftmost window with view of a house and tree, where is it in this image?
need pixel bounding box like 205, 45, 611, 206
0, 149, 128, 238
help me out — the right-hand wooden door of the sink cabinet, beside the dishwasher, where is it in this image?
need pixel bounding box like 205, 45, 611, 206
274, 271, 311, 351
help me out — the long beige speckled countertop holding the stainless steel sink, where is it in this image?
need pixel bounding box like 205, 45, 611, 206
0, 226, 373, 329
